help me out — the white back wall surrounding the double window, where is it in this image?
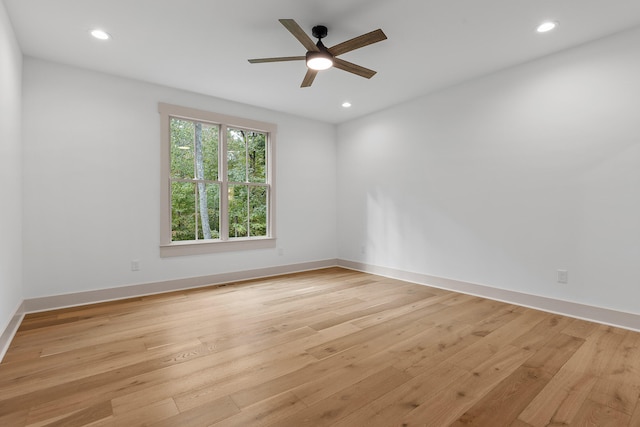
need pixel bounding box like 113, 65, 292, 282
23, 58, 336, 298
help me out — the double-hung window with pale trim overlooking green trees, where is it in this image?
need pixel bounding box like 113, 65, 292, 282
158, 103, 276, 256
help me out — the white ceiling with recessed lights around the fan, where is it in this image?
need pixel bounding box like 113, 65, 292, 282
3, 0, 640, 123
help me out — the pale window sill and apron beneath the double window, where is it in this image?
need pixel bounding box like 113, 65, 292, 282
160, 237, 276, 258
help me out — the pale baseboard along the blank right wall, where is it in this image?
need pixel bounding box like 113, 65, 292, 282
338, 259, 640, 331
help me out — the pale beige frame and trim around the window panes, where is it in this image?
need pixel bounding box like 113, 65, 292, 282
158, 102, 277, 257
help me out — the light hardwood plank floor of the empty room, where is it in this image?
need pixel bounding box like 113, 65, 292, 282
0, 268, 640, 427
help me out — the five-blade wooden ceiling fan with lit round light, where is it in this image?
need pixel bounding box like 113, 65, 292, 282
249, 19, 387, 87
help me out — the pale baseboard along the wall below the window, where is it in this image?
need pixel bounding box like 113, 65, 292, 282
24, 259, 338, 313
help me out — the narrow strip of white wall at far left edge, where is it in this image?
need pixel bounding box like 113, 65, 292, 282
0, 1, 22, 332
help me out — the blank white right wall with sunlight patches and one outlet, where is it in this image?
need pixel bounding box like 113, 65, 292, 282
338, 25, 640, 314
